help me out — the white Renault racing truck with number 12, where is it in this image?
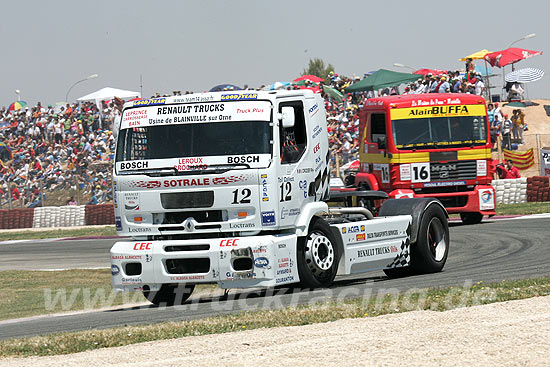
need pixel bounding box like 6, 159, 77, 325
111, 90, 449, 305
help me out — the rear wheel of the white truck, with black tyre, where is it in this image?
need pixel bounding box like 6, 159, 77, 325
410, 205, 449, 274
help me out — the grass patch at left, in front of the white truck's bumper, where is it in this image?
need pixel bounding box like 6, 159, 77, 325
0, 269, 218, 320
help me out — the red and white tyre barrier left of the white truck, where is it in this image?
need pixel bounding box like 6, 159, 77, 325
0, 204, 115, 229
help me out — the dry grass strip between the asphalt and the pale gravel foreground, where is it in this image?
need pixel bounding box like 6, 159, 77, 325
0, 277, 550, 357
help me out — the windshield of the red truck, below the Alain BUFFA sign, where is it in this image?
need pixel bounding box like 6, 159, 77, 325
392, 116, 487, 149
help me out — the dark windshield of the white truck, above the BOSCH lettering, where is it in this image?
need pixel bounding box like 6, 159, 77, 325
116, 121, 272, 162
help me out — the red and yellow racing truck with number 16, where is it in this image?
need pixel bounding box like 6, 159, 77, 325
347, 94, 495, 224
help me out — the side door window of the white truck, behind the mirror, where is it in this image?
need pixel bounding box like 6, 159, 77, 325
279, 101, 307, 164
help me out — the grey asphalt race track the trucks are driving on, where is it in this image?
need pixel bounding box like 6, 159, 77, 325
0, 217, 550, 339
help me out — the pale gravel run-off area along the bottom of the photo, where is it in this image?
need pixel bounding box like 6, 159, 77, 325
0, 296, 550, 367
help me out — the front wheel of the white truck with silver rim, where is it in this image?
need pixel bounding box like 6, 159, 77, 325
297, 217, 340, 288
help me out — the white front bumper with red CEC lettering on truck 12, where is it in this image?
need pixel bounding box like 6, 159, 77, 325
111, 234, 300, 291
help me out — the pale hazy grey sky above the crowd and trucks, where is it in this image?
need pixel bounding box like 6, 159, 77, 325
0, 0, 550, 106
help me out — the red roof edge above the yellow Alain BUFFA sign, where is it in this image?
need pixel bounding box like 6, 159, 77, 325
363, 93, 485, 108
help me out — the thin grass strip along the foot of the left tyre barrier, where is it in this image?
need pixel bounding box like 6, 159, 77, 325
0, 225, 116, 241
